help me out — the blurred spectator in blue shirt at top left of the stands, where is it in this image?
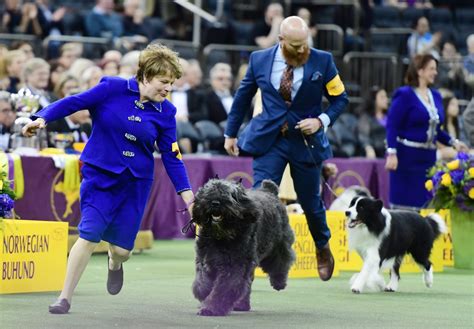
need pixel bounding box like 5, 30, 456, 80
85, 0, 124, 39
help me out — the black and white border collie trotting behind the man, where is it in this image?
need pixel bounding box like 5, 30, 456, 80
346, 197, 446, 293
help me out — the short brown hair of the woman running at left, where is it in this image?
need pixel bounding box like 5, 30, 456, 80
137, 43, 183, 82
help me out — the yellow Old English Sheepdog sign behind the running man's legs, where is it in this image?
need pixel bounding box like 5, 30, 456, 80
255, 212, 344, 278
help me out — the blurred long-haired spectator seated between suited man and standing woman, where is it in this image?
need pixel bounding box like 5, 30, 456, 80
357, 86, 388, 159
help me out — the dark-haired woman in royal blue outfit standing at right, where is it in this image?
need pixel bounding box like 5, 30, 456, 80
385, 54, 468, 209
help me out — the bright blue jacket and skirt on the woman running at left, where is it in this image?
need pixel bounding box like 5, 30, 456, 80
36, 77, 191, 250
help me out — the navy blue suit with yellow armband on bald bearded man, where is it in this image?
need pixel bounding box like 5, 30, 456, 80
225, 44, 348, 248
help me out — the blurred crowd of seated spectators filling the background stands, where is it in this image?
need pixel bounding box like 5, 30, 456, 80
0, 0, 474, 158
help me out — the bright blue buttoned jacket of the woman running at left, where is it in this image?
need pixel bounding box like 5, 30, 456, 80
35, 77, 190, 192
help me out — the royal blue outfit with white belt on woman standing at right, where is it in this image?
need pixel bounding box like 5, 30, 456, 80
387, 86, 451, 209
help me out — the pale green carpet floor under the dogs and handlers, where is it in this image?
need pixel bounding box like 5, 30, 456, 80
0, 240, 474, 329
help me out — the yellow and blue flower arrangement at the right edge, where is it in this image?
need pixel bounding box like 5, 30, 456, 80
425, 152, 474, 212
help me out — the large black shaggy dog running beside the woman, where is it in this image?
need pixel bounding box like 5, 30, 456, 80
193, 179, 295, 316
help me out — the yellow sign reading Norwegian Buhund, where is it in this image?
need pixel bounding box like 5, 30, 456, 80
0, 219, 68, 294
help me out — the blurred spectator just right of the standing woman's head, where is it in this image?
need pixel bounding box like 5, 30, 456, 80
438, 41, 464, 92
